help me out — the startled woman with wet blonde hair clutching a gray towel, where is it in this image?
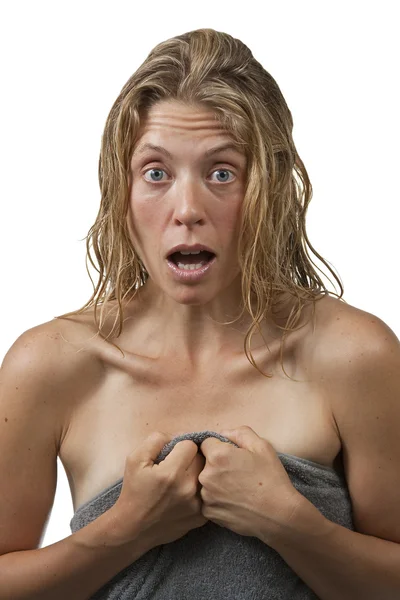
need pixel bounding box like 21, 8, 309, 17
0, 29, 400, 600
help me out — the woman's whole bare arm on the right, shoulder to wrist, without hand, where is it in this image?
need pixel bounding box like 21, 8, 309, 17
262, 311, 400, 600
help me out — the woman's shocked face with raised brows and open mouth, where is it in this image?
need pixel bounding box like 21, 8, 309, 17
128, 100, 246, 304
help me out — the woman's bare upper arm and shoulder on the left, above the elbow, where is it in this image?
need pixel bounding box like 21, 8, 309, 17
0, 320, 108, 555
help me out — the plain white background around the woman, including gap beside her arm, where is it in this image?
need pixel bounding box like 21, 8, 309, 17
0, 0, 400, 546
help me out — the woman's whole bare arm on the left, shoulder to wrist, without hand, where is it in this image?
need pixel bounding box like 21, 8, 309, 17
0, 324, 150, 600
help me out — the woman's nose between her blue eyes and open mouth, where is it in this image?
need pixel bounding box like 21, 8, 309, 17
172, 178, 205, 227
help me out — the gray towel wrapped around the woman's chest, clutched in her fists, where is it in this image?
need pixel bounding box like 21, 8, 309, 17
70, 431, 354, 600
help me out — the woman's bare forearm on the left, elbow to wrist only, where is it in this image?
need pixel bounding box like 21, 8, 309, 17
0, 509, 150, 600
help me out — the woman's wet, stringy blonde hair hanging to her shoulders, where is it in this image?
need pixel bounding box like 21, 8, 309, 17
55, 29, 345, 377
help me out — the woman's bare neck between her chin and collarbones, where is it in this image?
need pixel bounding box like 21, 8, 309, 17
122, 279, 287, 367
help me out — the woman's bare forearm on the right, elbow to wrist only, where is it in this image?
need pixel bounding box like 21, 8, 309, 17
260, 492, 400, 600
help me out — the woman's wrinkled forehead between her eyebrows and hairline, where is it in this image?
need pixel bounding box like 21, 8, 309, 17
135, 100, 244, 154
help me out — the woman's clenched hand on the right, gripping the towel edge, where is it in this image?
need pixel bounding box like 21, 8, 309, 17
198, 425, 308, 545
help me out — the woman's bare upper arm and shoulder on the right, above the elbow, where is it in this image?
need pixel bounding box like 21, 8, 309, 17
316, 306, 400, 543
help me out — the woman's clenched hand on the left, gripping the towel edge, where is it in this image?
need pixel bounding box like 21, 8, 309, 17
111, 431, 208, 548
